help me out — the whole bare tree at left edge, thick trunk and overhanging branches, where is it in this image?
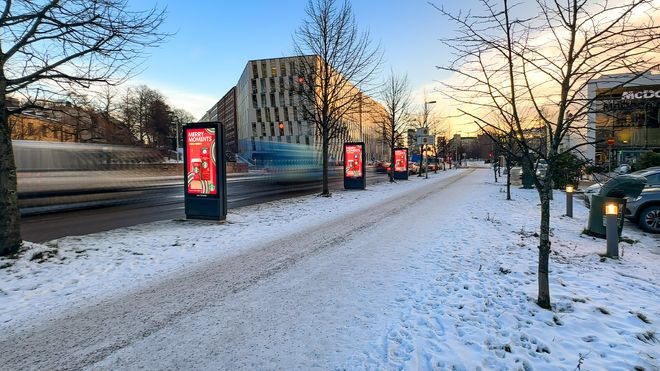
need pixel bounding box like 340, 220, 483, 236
0, 0, 165, 255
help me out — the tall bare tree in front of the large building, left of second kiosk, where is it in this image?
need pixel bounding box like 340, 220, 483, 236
292, 0, 381, 196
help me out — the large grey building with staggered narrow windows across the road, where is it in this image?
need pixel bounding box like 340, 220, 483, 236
201, 56, 388, 162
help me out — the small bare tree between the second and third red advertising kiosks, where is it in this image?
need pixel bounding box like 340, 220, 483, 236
379, 72, 410, 182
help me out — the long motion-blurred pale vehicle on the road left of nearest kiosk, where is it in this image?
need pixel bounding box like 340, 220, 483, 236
12, 140, 178, 209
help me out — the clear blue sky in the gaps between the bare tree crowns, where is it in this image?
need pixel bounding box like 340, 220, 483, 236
130, 0, 474, 118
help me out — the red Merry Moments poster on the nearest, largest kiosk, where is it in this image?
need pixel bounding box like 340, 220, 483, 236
186, 128, 218, 195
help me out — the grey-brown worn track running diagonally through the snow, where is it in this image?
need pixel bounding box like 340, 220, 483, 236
0, 169, 474, 370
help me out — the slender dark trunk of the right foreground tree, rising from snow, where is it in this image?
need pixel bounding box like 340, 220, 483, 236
537, 182, 552, 309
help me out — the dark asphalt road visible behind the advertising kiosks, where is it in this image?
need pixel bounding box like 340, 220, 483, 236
21, 169, 387, 242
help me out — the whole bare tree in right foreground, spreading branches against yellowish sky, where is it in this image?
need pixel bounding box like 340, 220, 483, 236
436, 0, 660, 308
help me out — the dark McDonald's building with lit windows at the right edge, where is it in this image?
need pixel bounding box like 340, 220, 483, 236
588, 73, 660, 165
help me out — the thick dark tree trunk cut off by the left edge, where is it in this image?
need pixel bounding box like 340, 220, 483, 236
0, 87, 21, 255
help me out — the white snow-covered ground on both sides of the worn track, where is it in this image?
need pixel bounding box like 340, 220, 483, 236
0, 169, 660, 370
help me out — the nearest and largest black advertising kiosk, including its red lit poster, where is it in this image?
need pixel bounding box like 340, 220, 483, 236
183, 122, 227, 220
